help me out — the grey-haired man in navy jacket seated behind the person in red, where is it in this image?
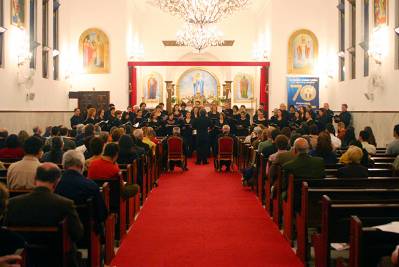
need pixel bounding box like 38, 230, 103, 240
55, 150, 108, 233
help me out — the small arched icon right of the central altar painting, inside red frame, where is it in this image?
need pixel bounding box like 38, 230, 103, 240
233, 73, 254, 102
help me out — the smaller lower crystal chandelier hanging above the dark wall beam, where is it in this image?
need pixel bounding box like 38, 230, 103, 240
177, 23, 224, 53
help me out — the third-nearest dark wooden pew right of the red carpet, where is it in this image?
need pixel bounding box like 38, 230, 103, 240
291, 178, 399, 262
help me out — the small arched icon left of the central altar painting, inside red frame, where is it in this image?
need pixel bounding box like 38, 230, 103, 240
143, 72, 163, 103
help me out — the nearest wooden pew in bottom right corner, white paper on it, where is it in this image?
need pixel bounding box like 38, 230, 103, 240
348, 215, 399, 267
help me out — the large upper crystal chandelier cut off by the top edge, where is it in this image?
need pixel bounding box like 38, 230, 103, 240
152, 0, 250, 25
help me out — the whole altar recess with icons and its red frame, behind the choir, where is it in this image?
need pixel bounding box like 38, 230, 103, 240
128, 61, 270, 109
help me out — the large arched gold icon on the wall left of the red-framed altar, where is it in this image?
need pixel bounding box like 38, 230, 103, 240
79, 28, 109, 74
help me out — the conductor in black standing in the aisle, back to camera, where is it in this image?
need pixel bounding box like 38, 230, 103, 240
193, 109, 212, 165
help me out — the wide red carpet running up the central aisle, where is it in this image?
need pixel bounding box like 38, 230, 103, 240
111, 162, 302, 267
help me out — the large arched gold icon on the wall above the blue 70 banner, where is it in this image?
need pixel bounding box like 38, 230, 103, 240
288, 29, 319, 74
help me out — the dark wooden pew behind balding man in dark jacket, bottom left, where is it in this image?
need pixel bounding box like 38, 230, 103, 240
7, 220, 72, 267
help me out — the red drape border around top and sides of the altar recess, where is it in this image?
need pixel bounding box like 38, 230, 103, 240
128, 61, 270, 111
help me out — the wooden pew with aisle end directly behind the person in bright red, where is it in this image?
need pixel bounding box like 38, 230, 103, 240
93, 177, 127, 242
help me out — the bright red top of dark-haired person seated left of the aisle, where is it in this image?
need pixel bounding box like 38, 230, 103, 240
87, 158, 120, 179
